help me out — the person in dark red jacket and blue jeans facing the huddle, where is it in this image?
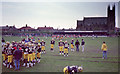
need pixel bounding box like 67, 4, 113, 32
13, 46, 22, 70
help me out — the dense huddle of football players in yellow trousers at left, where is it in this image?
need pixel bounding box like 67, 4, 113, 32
2, 40, 41, 68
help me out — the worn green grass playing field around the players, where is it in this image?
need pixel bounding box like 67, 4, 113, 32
2, 36, 118, 72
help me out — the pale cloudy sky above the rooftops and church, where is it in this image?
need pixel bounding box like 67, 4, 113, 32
2, 2, 118, 29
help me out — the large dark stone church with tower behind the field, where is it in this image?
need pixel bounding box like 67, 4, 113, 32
76, 5, 115, 32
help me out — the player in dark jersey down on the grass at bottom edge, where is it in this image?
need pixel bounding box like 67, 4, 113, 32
63, 66, 83, 74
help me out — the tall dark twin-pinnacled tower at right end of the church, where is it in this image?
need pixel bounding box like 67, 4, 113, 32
107, 4, 115, 32
